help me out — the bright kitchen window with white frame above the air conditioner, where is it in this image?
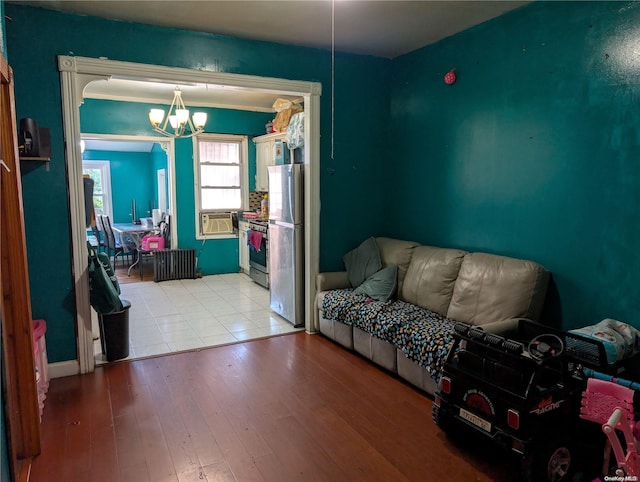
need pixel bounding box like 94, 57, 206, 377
194, 134, 248, 238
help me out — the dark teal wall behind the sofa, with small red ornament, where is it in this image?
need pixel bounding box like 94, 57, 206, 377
388, 2, 640, 328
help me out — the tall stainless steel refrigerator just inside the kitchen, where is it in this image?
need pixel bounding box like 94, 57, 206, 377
268, 164, 304, 326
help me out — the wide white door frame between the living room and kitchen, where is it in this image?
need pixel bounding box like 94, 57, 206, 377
58, 55, 322, 373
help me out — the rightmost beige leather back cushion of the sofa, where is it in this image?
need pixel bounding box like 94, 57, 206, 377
447, 253, 549, 325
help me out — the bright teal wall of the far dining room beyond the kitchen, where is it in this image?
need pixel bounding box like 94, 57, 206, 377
82, 150, 156, 223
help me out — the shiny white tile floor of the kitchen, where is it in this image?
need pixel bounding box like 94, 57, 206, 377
94, 273, 303, 364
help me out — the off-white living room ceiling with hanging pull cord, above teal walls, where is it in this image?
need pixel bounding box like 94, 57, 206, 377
6, 0, 530, 58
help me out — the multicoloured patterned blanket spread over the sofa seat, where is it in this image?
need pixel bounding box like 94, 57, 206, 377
322, 289, 455, 381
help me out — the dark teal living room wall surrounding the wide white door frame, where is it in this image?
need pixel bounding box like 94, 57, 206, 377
5, 4, 391, 362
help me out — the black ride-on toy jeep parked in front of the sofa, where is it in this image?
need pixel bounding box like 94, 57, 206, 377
433, 320, 606, 482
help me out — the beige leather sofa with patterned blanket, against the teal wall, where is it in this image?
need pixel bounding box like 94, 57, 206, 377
315, 238, 549, 394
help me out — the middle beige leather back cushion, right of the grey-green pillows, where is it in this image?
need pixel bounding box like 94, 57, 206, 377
402, 246, 466, 316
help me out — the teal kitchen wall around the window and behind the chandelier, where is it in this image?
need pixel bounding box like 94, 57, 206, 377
80, 99, 273, 275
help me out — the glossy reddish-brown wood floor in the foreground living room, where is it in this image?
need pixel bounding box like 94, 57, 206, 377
30, 333, 517, 482
